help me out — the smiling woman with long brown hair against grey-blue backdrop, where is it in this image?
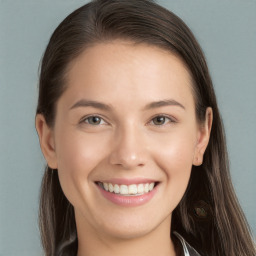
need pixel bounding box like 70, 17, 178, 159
36, 0, 255, 256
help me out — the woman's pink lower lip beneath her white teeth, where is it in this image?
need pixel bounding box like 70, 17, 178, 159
97, 185, 157, 206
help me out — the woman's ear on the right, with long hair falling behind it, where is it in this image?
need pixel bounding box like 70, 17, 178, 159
193, 107, 213, 166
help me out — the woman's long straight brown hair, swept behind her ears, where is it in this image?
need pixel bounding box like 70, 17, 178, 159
37, 0, 256, 256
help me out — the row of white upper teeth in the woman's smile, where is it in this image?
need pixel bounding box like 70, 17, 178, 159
99, 182, 155, 195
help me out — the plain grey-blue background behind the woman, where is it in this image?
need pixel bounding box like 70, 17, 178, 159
0, 0, 256, 256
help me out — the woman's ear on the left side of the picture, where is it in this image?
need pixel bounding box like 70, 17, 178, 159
36, 114, 58, 169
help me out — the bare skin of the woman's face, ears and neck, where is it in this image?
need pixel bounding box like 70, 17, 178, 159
36, 40, 212, 256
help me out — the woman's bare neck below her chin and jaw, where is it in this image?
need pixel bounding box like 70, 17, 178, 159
76, 210, 176, 256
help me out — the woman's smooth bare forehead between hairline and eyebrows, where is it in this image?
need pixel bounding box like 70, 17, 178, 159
61, 41, 193, 110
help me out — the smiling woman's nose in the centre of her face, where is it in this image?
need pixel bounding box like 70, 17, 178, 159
110, 127, 146, 170
